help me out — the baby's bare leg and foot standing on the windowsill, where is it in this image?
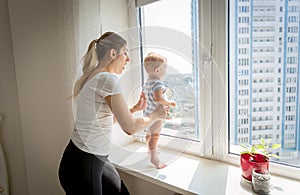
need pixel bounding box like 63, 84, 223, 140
146, 121, 167, 169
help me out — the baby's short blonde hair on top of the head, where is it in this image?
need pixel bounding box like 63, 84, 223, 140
144, 52, 167, 74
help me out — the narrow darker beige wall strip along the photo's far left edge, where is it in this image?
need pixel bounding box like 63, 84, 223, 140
0, 0, 28, 195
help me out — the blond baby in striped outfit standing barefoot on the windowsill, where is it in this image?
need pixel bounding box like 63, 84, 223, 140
143, 52, 176, 169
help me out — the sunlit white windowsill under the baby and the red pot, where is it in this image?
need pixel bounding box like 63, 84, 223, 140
110, 142, 300, 195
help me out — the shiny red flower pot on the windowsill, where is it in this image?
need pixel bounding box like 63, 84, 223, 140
240, 153, 269, 181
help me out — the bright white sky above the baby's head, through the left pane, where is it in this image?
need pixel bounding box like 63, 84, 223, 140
144, 0, 192, 74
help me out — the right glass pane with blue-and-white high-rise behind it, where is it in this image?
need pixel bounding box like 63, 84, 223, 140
229, 0, 300, 167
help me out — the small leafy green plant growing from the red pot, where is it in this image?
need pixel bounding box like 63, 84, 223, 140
241, 138, 281, 158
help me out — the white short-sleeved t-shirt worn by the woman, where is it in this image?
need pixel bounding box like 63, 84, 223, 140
71, 72, 122, 156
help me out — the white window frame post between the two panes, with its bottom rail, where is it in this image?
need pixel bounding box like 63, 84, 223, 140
136, 0, 300, 180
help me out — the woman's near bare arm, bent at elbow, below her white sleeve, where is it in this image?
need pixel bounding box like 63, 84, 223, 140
105, 94, 167, 135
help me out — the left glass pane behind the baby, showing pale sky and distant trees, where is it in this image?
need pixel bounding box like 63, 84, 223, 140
142, 0, 199, 139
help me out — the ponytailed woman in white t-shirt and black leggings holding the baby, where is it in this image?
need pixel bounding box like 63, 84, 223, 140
59, 32, 167, 195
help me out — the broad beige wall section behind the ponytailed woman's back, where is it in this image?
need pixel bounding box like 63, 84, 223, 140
8, 0, 70, 195
